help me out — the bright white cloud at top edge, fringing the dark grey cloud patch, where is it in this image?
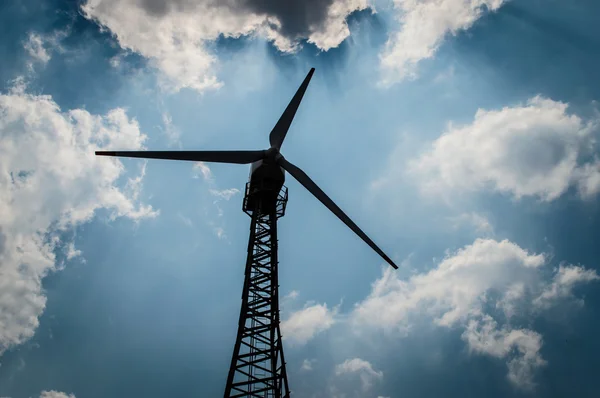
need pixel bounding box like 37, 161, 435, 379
81, 0, 367, 91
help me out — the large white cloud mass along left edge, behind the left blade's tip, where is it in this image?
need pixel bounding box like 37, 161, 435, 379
0, 81, 158, 354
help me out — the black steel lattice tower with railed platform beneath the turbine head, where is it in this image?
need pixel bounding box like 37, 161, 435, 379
225, 183, 290, 398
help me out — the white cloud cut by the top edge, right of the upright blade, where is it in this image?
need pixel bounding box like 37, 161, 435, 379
380, 0, 506, 85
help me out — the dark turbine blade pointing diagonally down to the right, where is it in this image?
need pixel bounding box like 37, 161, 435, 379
277, 157, 398, 269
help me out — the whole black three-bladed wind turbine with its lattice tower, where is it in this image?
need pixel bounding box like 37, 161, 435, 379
96, 68, 398, 398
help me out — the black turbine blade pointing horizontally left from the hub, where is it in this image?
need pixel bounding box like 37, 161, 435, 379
96, 151, 265, 164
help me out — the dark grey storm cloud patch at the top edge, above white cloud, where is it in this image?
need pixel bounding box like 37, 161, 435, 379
138, 0, 346, 38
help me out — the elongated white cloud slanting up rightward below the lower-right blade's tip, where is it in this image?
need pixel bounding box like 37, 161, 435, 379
354, 239, 545, 332
